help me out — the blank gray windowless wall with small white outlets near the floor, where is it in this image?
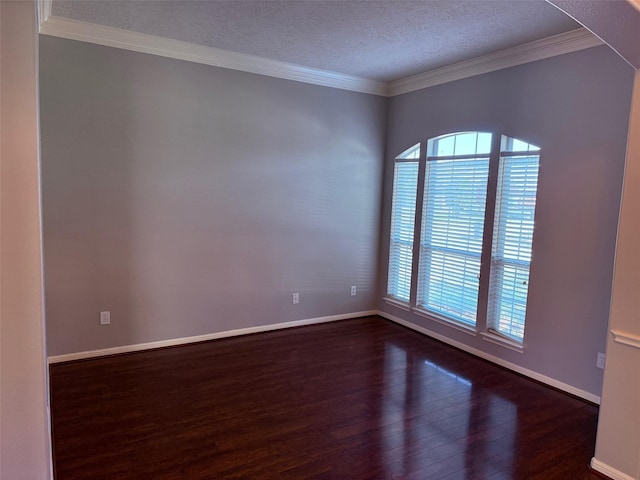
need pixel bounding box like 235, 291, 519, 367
40, 36, 387, 355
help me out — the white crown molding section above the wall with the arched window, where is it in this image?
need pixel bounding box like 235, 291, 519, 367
389, 28, 603, 97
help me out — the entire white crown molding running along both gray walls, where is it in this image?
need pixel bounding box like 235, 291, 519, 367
38, 13, 603, 97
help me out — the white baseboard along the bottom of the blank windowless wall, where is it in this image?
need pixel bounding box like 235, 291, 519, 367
48, 310, 378, 364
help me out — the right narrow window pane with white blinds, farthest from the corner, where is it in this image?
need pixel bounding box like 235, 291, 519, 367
487, 137, 540, 342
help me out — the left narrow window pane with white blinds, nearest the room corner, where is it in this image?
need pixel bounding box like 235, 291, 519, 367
387, 144, 420, 303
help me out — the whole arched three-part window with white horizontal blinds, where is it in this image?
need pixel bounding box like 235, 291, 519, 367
387, 132, 540, 345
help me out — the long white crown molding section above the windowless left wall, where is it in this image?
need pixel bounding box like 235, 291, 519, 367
40, 15, 387, 96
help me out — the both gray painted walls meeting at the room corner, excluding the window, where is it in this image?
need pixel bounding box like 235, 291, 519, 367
40, 36, 633, 395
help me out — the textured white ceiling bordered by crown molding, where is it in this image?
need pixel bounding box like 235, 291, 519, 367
52, 0, 580, 81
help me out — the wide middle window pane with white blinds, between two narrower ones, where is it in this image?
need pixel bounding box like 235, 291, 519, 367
417, 132, 491, 325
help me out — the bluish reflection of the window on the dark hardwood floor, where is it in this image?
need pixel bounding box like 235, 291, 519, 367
380, 343, 518, 480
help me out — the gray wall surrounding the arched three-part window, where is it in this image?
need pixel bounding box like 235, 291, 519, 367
378, 47, 633, 395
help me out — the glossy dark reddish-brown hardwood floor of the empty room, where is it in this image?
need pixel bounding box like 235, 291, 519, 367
51, 317, 601, 480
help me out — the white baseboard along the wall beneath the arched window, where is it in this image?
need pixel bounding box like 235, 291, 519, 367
378, 311, 600, 405
